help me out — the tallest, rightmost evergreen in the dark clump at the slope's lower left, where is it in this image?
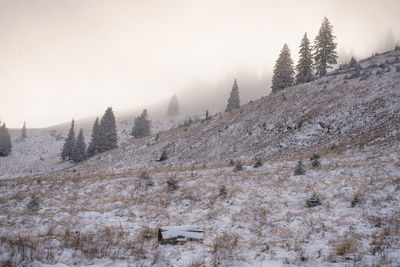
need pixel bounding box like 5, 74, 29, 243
99, 107, 118, 152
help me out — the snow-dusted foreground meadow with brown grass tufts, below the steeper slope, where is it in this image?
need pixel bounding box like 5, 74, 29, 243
0, 145, 400, 266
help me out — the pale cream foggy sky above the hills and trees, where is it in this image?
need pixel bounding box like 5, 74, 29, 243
0, 0, 400, 127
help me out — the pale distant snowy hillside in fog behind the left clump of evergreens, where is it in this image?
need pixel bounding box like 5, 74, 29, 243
0, 114, 192, 179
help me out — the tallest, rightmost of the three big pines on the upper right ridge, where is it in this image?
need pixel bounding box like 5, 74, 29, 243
313, 17, 337, 77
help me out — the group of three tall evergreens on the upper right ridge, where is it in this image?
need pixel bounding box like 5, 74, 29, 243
271, 17, 337, 93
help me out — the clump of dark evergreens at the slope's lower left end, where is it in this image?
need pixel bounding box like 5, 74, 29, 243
61, 107, 118, 162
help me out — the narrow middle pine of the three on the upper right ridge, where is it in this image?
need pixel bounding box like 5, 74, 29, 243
296, 33, 313, 84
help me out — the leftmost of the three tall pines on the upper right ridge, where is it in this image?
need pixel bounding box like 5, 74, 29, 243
271, 44, 294, 93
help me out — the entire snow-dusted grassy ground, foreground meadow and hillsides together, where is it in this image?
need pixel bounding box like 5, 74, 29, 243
0, 50, 400, 266
